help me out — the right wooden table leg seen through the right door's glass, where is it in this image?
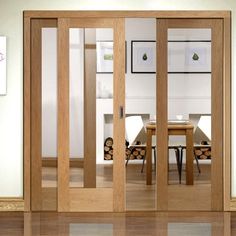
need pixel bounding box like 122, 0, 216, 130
186, 129, 193, 185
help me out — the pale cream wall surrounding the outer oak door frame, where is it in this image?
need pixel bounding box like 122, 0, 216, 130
0, 0, 236, 197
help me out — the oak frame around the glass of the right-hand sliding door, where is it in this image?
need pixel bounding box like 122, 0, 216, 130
156, 19, 223, 211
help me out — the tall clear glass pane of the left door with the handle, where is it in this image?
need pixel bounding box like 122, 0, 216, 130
70, 28, 113, 188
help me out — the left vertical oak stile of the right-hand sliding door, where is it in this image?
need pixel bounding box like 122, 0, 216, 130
156, 19, 168, 211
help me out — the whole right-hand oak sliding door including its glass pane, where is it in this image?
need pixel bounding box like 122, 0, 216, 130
157, 19, 223, 211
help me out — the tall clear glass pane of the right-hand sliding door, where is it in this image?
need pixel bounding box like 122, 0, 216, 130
168, 29, 211, 186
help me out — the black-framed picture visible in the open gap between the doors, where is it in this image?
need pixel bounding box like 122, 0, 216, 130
131, 40, 156, 73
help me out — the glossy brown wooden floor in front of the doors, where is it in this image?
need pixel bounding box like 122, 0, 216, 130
0, 212, 236, 236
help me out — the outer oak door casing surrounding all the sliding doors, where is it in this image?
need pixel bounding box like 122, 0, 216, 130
23, 11, 230, 211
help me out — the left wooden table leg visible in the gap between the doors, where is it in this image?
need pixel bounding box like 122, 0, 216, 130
146, 130, 152, 185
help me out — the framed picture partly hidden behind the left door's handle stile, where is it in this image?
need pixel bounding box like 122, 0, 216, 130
96, 40, 126, 74
